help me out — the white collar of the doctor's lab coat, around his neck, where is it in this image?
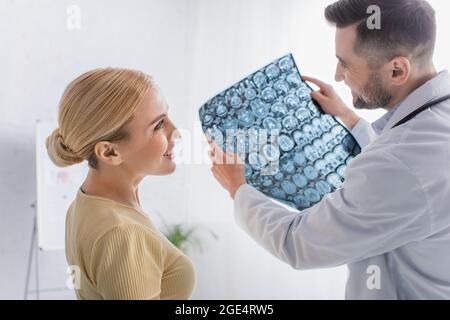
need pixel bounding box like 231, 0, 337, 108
380, 70, 450, 133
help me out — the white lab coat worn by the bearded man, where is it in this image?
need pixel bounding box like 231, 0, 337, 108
234, 71, 450, 299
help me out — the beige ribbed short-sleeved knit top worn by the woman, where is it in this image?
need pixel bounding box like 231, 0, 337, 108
65, 190, 195, 300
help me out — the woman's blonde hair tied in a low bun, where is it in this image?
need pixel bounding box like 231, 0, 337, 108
46, 68, 153, 169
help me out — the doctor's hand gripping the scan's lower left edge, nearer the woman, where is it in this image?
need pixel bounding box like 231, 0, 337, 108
208, 139, 247, 199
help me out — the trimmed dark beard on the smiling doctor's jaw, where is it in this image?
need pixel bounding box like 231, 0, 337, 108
354, 72, 392, 110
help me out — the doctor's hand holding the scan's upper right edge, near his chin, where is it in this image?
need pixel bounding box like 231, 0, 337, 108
302, 76, 360, 130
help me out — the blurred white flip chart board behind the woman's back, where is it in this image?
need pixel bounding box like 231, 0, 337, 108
36, 121, 88, 250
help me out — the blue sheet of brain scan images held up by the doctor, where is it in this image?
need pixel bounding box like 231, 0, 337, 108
199, 54, 361, 210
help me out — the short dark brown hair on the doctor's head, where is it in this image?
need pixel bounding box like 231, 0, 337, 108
325, 0, 436, 68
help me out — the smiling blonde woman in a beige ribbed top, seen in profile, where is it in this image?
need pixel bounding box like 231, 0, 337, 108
46, 68, 195, 299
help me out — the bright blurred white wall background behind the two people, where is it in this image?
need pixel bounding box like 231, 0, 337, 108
0, 0, 450, 299
